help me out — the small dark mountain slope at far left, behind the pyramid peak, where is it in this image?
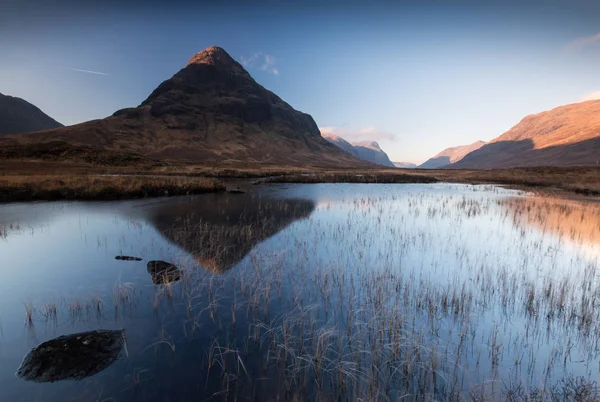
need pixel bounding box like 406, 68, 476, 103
0, 94, 62, 135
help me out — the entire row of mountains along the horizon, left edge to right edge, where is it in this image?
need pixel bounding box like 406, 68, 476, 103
0, 46, 600, 169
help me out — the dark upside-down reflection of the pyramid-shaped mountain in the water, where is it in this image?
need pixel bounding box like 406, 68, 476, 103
146, 194, 314, 272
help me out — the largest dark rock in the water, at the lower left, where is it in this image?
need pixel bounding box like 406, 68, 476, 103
17, 330, 125, 382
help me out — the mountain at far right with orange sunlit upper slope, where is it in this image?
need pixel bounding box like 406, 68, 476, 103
448, 101, 600, 169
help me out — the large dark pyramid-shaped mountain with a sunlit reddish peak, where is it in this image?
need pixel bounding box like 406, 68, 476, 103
0, 47, 364, 167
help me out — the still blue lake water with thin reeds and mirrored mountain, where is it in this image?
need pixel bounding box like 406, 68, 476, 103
0, 184, 600, 402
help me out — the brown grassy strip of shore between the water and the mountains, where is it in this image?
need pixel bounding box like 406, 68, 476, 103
0, 160, 600, 202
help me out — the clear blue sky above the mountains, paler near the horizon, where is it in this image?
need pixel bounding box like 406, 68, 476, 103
0, 0, 600, 162
